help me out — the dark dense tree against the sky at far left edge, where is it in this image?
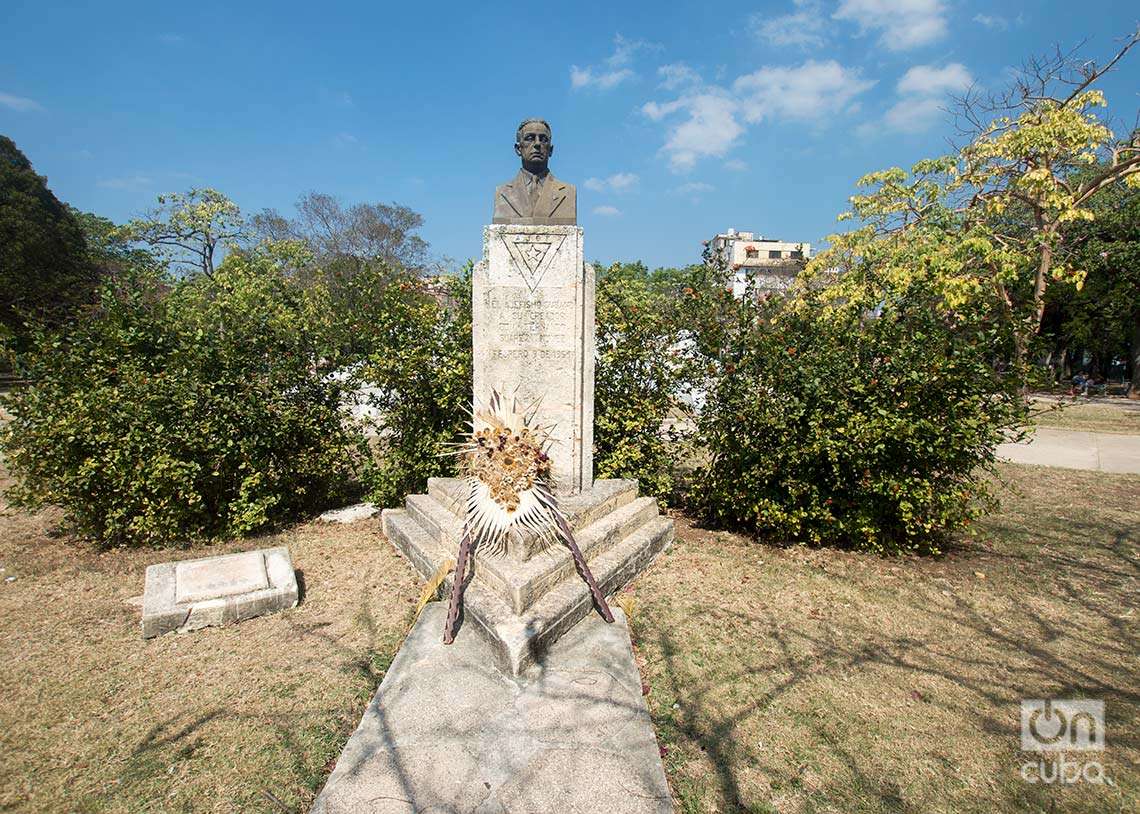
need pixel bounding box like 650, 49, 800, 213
0, 136, 97, 337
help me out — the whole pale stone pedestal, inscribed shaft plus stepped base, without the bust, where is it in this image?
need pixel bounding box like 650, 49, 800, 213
383, 225, 673, 675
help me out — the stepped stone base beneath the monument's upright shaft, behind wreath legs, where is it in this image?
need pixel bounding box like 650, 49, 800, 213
383, 478, 673, 675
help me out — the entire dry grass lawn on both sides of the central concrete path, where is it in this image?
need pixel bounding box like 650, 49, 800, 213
0, 466, 1140, 813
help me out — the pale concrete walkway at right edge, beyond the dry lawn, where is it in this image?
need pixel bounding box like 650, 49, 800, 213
998, 428, 1140, 474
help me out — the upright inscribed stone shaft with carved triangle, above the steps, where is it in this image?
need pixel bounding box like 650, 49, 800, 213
471, 225, 594, 495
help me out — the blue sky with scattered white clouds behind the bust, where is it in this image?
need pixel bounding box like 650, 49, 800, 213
0, 0, 1140, 266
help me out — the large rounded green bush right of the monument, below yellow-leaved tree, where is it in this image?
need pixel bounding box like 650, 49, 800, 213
692, 275, 1025, 553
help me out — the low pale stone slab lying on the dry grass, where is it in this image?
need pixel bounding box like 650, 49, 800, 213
143, 546, 299, 638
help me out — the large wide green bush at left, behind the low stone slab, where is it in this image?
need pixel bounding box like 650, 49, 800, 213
0, 254, 361, 546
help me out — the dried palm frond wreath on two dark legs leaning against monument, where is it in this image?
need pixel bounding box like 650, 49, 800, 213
443, 391, 613, 644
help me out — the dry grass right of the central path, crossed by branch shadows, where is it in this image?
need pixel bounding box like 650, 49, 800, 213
630, 465, 1140, 814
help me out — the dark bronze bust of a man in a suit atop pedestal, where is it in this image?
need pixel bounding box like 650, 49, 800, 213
491, 119, 578, 226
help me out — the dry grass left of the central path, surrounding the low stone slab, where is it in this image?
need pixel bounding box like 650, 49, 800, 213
0, 471, 417, 813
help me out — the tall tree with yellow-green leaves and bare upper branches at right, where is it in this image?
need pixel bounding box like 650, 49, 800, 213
804, 32, 1140, 377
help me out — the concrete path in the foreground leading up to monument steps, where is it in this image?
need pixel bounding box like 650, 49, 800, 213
312, 602, 673, 814
